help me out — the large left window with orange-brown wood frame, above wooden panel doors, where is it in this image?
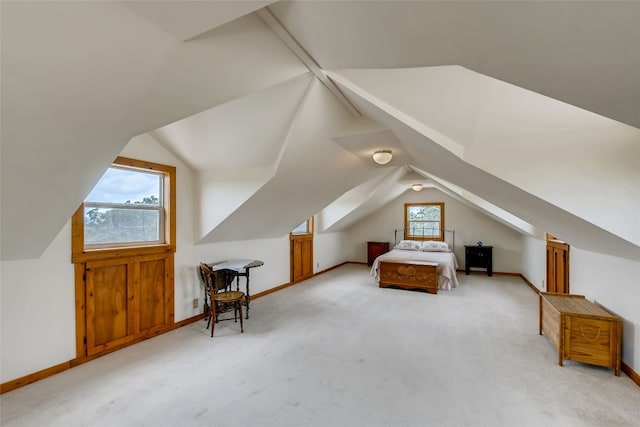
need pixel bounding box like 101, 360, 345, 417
73, 157, 175, 255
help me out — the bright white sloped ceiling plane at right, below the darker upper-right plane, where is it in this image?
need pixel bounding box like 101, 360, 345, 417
330, 67, 640, 258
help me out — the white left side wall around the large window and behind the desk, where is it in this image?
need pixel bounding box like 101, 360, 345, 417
0, 135, 348, 383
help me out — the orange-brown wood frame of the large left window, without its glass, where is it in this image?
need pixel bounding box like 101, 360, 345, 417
71, 157, 176, 263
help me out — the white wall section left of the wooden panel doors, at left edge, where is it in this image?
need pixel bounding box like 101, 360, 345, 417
0, 221, 76, 383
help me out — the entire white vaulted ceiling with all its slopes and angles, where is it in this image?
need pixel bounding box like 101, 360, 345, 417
0, 0, 640, 259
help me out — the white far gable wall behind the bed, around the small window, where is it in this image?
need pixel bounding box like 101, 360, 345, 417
348, 188, 522, 273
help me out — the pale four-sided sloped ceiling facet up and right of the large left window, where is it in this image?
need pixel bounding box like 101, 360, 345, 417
149, 73, 311, 172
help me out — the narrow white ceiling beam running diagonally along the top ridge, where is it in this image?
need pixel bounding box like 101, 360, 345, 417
256, 7, 362, 117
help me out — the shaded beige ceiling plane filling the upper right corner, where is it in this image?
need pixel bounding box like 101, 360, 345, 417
269, 1, 640, 127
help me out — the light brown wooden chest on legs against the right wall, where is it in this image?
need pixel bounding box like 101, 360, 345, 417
539, 292, 622, 376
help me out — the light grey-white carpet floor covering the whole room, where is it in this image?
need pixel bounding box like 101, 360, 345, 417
0, 264, 640, 427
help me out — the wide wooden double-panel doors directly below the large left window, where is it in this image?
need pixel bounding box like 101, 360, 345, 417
84, 254, 173, 355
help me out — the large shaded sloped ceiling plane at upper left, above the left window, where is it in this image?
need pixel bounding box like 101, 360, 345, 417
0, 1, 308, 259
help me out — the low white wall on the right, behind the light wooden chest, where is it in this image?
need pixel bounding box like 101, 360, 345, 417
522, 238, 640, 372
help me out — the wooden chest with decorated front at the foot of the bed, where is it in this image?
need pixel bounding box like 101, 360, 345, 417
378, 261, 438, 294
